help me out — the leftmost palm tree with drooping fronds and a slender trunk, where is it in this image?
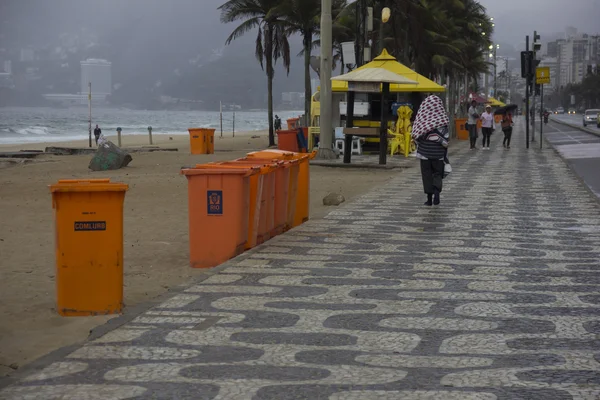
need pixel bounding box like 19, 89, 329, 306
218, 0, 291, 146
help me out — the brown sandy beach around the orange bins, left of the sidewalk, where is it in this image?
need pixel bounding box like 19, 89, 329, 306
0, 131, 400, 376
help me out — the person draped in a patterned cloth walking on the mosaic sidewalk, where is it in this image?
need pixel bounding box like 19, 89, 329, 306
411, 96, 450, 206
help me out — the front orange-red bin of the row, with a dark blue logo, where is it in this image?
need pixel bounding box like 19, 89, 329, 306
181, 168, 259, 268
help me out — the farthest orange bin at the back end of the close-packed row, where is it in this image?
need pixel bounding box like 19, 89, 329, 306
247, 150, 316, 227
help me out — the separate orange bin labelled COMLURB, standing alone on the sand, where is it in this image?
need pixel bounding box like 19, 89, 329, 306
50, 179, 128, 316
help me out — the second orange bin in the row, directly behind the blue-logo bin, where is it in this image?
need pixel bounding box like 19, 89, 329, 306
196, 161, 273, 250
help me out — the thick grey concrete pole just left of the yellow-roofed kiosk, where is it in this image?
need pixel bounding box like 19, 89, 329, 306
317, 0, 336, 160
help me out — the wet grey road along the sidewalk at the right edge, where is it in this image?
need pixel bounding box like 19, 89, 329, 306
536, 119, 600, 197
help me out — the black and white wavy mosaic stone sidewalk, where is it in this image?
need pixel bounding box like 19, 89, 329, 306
0, 119, 600, 400
